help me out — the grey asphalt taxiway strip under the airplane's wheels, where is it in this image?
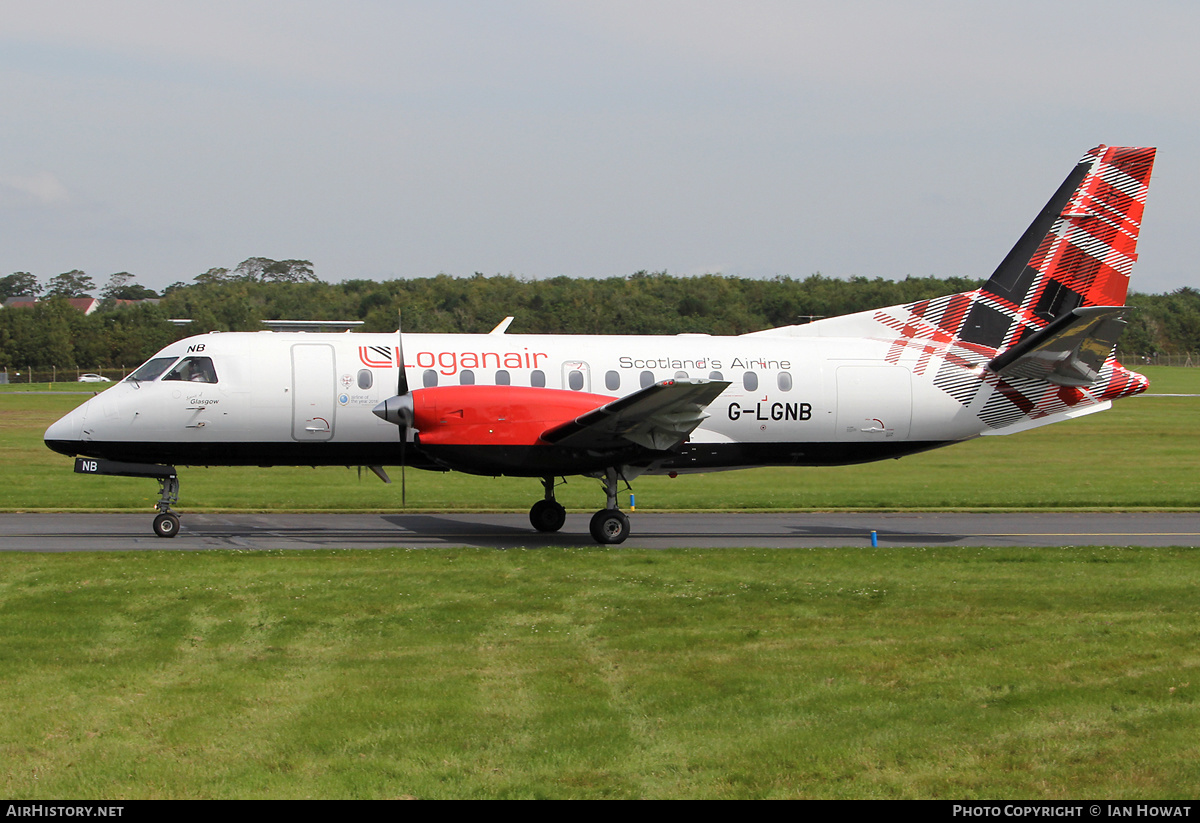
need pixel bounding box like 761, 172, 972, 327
0, 512, 1200, 552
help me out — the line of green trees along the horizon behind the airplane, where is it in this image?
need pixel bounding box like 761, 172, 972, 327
0, 267, 1200, 370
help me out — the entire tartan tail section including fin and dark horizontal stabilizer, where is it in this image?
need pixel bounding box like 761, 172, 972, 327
849, 145, 1154, 433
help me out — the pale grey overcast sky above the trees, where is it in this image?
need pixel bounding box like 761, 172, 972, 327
0, 0, 1200, 296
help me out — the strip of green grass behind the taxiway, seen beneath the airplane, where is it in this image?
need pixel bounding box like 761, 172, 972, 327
0, 367, 1200, 512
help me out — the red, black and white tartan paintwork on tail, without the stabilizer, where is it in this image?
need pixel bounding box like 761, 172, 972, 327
874, 145, 1154, 428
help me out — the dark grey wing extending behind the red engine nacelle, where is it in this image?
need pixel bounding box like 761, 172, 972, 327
541, 378, 730, 451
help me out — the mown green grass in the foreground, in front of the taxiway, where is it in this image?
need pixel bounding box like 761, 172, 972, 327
0, 548, 1200, 799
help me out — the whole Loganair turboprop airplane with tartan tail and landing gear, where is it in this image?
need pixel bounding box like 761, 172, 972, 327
46, 146, 1154, 543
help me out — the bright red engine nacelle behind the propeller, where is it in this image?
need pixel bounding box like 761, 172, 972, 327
413, 386, 616, 446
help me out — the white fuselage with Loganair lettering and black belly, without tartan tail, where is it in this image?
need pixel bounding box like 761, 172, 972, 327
46, 332, 985, 474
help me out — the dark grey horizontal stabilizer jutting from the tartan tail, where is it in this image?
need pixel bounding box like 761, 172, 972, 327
989, 306, 1129, 386
